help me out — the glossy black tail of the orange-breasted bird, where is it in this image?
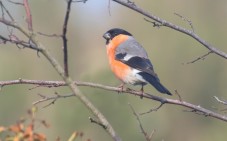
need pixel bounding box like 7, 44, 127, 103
139, 72, 172, 95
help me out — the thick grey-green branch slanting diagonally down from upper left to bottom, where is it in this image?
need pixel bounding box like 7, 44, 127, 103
0, 2, 121, 141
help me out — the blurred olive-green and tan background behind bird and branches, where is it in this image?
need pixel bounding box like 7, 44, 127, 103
0, 0, 227, 141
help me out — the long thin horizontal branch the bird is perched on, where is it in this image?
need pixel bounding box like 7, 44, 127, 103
0, 79, 227, 122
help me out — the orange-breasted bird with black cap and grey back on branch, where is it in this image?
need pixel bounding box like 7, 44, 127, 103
103, 28, 172, 96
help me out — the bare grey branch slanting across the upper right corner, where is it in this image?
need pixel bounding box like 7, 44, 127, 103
112, 0, 227, 59
